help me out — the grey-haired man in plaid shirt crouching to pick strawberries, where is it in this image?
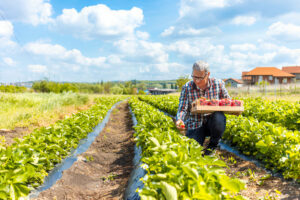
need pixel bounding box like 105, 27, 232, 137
176, 61, 230, 155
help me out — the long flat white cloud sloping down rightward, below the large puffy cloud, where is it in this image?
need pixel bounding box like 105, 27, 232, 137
24, 42, 106, 67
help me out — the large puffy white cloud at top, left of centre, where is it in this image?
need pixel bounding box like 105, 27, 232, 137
54, 4, 145, 39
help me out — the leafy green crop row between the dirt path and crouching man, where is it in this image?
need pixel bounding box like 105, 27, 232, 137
130, 98, 244, 200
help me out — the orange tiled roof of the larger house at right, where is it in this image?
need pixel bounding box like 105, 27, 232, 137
247, 67, 295, 77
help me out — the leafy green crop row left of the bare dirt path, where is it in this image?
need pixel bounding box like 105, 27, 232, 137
0, 97, 125, 199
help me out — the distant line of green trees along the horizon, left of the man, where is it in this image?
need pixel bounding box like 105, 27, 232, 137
0, 76, 189, 95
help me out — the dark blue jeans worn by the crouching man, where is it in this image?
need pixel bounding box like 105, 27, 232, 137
186, 112, 226, 148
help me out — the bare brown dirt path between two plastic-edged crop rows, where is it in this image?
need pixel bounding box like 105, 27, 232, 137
33, 102, 134, 200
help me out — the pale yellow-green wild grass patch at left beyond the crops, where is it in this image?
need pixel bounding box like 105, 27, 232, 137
0, 93, 93, 129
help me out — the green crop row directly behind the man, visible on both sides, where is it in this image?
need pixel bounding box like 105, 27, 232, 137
141, 96, 300, 181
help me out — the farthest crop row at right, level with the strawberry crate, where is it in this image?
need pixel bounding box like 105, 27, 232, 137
243, 98, 300, 130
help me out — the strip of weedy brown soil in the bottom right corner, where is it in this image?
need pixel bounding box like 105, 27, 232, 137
216, 145, 300, 200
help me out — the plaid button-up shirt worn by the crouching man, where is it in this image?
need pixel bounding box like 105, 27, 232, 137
176, 78, 230, 129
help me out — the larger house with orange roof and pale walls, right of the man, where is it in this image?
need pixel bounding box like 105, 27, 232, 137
244, 67, 296, 85
